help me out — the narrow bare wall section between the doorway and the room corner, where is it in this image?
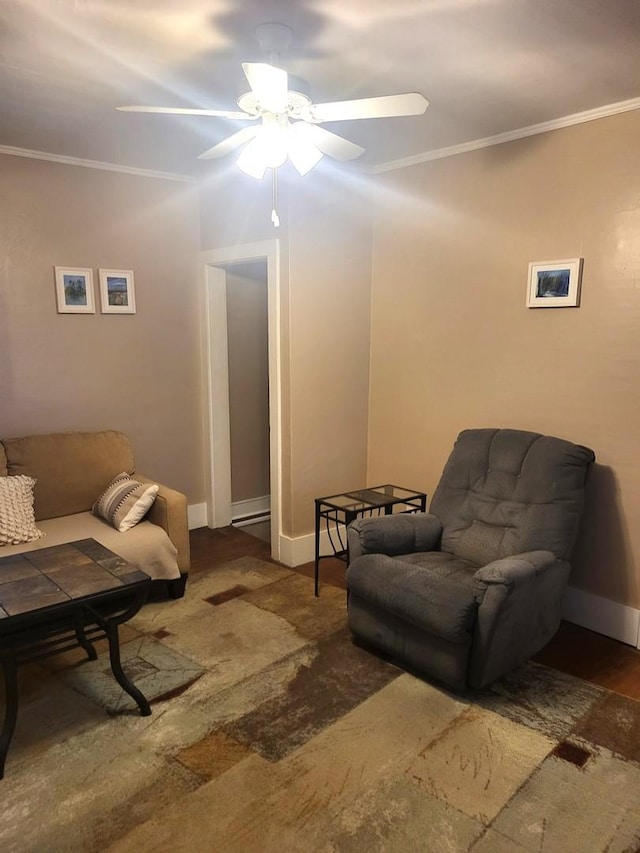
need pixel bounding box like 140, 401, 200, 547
289, 166, 372, 536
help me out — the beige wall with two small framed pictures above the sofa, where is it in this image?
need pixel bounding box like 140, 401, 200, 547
0, 155, 204, 503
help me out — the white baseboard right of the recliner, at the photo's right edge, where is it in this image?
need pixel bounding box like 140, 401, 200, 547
562, 587, 640, 648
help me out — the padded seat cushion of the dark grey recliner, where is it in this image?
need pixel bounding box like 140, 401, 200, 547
347, 552, 478, 643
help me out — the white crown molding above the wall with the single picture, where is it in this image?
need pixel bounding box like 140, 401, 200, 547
372, 98, 640, 175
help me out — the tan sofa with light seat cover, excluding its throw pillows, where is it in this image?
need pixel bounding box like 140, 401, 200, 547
0, 430, 190, 597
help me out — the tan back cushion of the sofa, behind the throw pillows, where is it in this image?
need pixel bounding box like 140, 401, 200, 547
3, 430, 135, 521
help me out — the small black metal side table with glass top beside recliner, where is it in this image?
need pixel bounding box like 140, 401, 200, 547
314, 484, 427, 596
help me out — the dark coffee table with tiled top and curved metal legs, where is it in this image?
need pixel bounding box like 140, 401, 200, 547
0, 539, 151, 779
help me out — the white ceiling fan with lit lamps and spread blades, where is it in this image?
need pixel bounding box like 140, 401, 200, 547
116, 24, 429, 179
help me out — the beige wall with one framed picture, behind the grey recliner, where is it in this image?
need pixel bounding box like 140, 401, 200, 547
368, 111, 640, 607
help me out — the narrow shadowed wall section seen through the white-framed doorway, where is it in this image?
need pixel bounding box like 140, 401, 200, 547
227, 261, 270, 503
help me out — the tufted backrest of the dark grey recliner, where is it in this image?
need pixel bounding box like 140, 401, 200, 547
430, 429, 595, 565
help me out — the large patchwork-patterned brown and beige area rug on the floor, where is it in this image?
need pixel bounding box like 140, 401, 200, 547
0, 558, 640, 853
